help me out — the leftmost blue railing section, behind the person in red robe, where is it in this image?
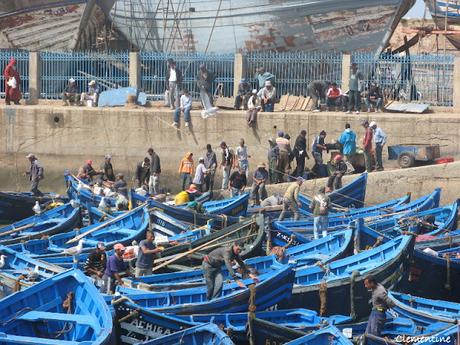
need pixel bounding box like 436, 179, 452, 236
0, 50, 29, 99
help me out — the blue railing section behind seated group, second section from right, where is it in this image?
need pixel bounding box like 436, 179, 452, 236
245, 51, 342, 95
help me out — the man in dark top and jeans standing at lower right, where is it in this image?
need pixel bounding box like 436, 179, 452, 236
364, 275, 394, 337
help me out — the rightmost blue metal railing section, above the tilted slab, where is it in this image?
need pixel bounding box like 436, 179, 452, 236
352, 53, 454, 106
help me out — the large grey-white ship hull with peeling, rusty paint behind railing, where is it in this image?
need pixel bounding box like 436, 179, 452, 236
110, 0, 414, 53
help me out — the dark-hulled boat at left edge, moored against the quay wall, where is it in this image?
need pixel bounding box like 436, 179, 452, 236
0, 192, 68, 223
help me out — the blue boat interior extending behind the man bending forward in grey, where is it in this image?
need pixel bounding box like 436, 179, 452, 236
129, 230, 353, 291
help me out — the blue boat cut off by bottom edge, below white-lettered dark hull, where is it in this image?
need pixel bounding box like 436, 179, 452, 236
138, 323, 234, 345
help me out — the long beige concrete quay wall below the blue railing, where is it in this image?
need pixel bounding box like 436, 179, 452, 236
0, 105, 460, 199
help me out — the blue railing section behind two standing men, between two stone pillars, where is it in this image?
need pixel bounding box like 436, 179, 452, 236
140, 52, 235, 99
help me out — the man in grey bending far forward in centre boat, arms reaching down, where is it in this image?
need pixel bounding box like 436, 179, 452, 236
203, 242, 258, 301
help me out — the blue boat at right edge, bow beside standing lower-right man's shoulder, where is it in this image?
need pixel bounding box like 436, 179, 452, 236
388, 291, 460, 325
